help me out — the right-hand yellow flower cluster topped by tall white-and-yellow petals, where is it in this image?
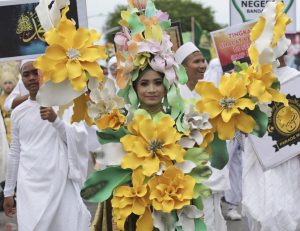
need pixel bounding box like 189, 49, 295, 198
196, 2, 290, 140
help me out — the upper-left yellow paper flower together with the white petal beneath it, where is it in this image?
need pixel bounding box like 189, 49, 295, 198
34, 6, 107, 106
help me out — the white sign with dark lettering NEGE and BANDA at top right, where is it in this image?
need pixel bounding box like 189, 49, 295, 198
230, 0, 296, 34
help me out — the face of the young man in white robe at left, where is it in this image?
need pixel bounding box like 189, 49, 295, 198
21, 62, 40, 95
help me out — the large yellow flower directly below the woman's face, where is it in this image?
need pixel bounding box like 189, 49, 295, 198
121, 115, 185, 176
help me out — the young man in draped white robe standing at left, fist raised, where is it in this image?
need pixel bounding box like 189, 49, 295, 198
4, 62, 90, 231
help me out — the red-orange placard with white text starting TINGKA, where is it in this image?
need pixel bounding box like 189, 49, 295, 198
210, 22, 256, 72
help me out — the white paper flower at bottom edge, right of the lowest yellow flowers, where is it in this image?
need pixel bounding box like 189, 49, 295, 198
176, 205, 203, 231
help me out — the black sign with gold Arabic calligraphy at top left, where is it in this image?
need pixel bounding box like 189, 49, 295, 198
0, 0, 87, 61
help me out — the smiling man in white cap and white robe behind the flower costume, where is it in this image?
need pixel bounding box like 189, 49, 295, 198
175, 42, 230, 231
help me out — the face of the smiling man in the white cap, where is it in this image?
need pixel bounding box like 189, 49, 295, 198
183, 51, 207, 81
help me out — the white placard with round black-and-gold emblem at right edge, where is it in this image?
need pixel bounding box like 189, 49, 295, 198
249, 75, 300, 170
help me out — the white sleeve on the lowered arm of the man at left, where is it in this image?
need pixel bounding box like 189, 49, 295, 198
4, 113, 21, 197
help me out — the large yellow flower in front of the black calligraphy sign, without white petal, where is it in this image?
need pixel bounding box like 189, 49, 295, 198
34, 6, 107, 91
